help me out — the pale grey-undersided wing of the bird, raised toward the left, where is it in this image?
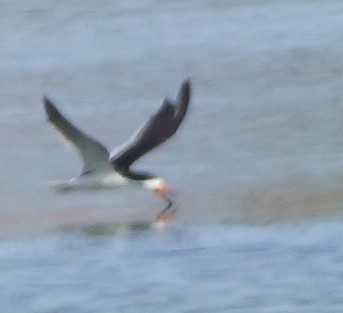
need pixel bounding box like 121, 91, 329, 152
43, 96, 113, 175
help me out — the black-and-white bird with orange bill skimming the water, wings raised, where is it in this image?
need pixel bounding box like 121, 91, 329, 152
43, 79, 191, 222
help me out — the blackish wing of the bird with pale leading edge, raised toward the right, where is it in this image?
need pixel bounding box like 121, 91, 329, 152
111, 80, 191, 172
